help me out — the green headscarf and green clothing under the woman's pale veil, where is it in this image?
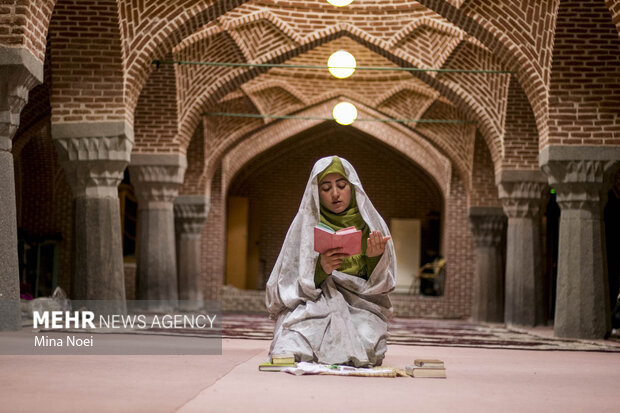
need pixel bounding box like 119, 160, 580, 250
314, 156, 378, 287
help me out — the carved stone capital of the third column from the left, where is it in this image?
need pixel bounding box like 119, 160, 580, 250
129, 153, 187, 210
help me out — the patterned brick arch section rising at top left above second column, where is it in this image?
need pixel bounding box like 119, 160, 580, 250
118, 0, 247, 124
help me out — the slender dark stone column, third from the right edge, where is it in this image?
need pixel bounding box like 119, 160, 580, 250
469, 207, 506, 323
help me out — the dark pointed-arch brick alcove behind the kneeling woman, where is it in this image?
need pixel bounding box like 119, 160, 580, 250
226, 122, 444, 289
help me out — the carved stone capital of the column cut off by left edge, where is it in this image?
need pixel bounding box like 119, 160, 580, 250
0, 46, 43, 152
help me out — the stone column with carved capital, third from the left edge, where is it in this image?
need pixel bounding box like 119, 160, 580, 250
129, 154, 187, 308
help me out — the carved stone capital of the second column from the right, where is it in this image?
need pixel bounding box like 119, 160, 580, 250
496, 170, 547, 218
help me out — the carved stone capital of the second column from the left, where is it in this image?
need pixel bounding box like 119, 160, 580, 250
52, 121, 133, 198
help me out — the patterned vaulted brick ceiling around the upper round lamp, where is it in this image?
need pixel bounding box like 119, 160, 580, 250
162, 0, 509, 181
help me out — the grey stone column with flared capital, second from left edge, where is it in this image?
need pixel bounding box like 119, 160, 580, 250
52, 121, 133, 312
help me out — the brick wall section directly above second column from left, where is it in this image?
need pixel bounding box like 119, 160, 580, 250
49, 0, 130, 123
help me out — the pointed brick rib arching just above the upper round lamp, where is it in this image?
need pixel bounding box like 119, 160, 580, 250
179, 28, 501, 166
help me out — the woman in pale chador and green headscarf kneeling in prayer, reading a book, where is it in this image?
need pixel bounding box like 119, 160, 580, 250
267, 156, 396, 367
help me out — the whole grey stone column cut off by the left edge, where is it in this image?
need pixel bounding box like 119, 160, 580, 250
0, 46, 43, 331
